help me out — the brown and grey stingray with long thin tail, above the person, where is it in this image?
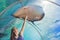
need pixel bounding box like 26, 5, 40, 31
13, 5, 44, 39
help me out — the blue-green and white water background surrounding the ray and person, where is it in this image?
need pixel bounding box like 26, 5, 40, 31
0, 0, 60, 40
